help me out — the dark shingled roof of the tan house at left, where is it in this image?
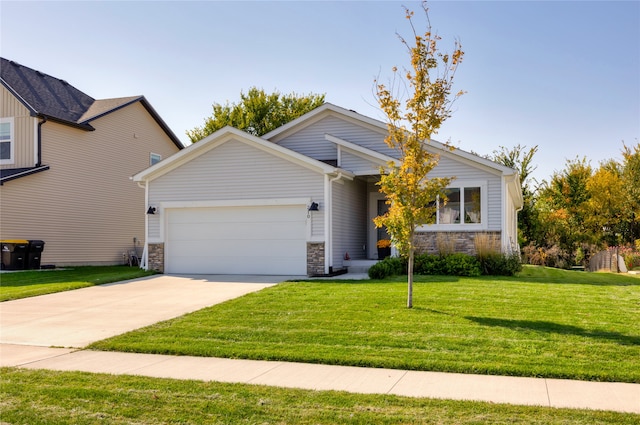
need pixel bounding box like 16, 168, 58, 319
0, 58, 184, 149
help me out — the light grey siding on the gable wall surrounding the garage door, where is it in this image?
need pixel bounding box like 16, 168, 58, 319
149, 140, 325, 241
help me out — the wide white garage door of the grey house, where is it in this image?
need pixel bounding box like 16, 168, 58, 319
165, 205, 307, 275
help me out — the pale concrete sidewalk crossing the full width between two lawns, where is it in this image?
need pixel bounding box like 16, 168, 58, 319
0, 344, 640, 414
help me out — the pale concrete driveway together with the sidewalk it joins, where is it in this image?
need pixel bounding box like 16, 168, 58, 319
0, 275, 640, 414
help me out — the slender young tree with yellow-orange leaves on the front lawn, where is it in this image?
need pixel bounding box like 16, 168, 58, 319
374, 3, 464, 308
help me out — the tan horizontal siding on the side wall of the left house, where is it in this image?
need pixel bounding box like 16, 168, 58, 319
0, 103, 178, 265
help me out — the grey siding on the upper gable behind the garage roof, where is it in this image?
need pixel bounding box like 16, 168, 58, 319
277, 116, 396, 160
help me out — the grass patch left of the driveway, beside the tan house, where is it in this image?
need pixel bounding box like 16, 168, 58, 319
0, 266, 153, 301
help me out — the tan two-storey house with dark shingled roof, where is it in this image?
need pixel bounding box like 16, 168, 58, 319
0, 58, 183, 265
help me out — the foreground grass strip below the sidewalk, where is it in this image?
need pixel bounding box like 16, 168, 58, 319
0, 368, 638, 425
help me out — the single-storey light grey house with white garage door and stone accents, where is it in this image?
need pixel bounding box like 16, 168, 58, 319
133, 104, 522, 276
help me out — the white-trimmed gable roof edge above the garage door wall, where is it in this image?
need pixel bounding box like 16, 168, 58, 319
131, 126, 353, 182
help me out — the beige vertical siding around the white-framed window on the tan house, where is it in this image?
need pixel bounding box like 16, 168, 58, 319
0, 86, 37, 168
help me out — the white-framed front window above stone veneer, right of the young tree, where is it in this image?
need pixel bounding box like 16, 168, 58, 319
433, 182, 487, 226
